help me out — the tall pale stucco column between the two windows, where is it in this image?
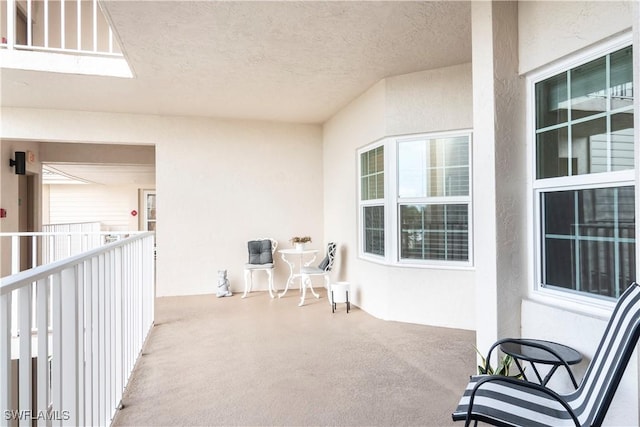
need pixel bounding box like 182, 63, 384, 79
471, 1, 528, 352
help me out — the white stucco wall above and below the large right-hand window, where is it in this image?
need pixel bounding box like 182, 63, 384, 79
518, 1, 640, 426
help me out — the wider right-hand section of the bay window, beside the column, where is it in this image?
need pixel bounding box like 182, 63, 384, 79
398, 136, 470, 262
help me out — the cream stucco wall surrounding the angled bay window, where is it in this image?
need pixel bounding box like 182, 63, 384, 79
324, 64, 475, 329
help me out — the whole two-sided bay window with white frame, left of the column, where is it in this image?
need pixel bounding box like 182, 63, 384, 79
359, 132, 471, 266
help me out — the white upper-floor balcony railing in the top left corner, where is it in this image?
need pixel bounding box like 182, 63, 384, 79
0, 0, 122, 56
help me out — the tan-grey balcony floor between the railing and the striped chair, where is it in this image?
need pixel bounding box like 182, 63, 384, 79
112, 290, 475, 426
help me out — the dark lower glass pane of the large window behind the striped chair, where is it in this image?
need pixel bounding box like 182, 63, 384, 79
542, 186, 635, 297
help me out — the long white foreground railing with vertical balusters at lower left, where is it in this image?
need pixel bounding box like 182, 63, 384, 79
0, 232, 155, 426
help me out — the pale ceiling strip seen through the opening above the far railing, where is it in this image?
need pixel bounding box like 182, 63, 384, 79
42, 163, 155, 186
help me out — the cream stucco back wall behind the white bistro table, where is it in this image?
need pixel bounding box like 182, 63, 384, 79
0, 108, 325, 298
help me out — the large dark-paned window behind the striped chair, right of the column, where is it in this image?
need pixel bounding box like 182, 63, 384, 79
533, 41, 635, 298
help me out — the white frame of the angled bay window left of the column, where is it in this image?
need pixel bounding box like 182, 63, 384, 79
357, 129, 474, 269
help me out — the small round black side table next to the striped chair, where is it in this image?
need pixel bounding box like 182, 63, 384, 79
500, 338, 582, 388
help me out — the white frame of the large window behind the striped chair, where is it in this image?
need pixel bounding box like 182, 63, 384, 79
526, 34, 640, 308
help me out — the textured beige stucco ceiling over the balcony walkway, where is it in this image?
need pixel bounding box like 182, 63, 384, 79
1, 0, 471, 123
